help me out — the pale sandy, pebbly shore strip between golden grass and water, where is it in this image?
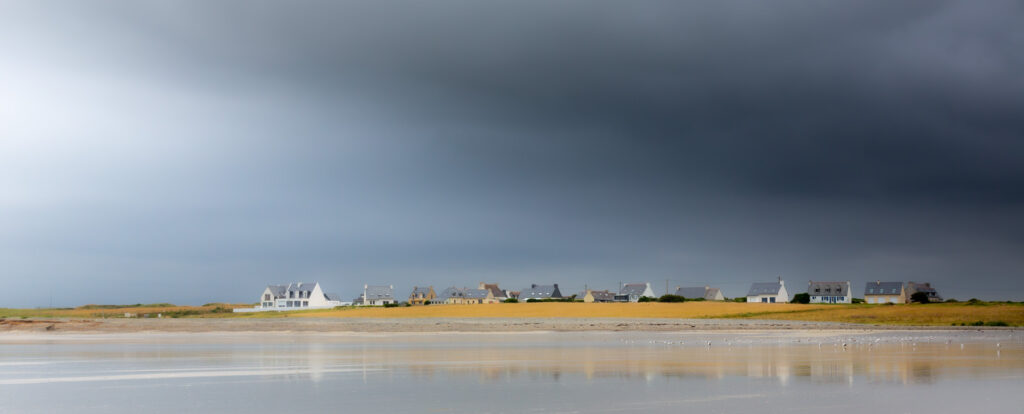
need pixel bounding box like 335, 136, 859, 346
0, 318, 1021, 335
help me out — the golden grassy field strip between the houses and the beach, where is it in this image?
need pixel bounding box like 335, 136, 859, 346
0, 301, 1024, 326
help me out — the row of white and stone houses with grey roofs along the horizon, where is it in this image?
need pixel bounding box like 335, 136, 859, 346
233, 278, 943, 313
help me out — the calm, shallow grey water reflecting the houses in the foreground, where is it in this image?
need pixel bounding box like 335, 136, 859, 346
0, 331, 1024, 413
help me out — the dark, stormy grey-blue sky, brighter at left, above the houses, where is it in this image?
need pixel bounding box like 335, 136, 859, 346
0, 0, 1024, 307
